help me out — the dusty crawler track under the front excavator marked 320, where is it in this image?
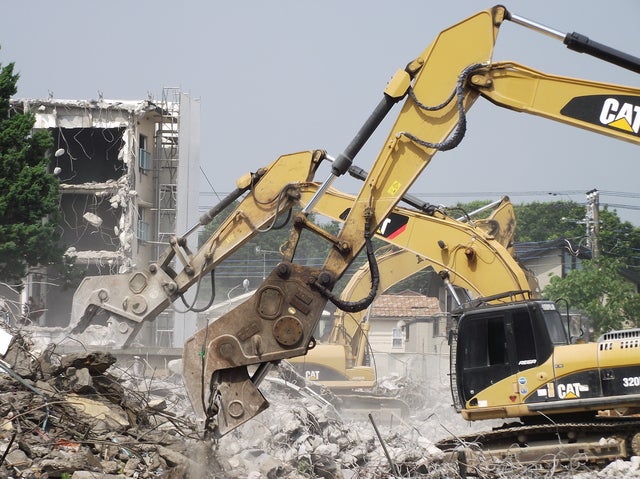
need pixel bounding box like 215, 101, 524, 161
436, 417, 640, 477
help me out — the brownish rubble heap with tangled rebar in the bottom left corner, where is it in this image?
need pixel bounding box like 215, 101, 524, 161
0, 330, 205, 479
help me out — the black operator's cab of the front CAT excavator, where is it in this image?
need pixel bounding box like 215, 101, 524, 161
451, 300, 569, 410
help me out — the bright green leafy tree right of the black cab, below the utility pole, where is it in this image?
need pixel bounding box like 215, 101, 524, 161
544, 257, 640, 334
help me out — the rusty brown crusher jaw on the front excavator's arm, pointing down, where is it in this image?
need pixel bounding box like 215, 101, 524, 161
183, 262, 327, 436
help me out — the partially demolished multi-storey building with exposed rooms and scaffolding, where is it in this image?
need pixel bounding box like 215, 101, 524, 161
12, 88, 200, 347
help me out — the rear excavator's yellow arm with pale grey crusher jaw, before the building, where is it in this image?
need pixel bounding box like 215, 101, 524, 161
67, 150, 325, 348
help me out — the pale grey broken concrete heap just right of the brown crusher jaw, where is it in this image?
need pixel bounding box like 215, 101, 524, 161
212, 381, 448, 479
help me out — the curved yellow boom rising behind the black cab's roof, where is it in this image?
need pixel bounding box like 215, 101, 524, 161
300, 185, 540, 298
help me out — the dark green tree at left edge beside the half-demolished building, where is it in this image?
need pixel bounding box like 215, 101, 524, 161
0, 59, 62, 285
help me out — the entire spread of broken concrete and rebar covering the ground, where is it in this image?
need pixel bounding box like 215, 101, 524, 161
0, 320, 640, 479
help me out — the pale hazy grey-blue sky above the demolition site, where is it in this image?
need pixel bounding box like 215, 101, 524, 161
5, 0, 640, 226
